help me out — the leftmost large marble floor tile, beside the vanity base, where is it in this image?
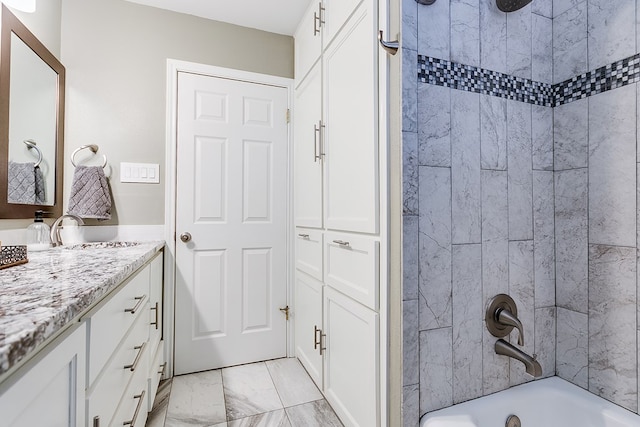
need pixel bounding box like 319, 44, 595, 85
165, 370, 226, 427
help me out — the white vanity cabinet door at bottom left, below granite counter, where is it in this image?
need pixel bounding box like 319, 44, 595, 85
0, 324, 87, 427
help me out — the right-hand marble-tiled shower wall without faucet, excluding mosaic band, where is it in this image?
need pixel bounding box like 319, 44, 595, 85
553, 0, 640, 412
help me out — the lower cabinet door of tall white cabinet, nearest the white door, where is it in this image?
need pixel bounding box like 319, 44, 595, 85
294, 271, 322, 389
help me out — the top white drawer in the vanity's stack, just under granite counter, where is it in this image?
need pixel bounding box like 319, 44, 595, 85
87, 266, 149, 385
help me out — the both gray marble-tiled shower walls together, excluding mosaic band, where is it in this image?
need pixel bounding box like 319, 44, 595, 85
402, 0, 640, 427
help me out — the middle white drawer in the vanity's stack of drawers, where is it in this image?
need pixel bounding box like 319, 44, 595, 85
87, 310, 149, 425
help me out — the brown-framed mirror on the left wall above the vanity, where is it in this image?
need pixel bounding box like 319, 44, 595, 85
0, 5, 65, 219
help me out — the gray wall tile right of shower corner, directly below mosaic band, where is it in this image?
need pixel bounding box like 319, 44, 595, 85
553, 99, 589, 171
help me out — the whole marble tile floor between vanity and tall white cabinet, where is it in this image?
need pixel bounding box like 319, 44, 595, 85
147, 358, 342, 427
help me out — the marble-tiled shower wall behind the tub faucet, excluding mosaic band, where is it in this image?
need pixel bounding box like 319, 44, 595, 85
402, 0, 556, 426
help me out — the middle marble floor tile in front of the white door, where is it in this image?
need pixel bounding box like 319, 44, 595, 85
222, 362, 283, 421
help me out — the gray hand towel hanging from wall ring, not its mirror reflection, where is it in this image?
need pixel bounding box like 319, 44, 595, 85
69, 166, 111, 219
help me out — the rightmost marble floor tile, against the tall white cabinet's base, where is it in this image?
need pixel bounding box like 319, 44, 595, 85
265, 358, 322, 408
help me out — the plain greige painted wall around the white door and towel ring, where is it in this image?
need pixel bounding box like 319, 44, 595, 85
62, 0, 293, 225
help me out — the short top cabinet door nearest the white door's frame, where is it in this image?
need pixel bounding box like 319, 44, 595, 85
293, 0, 322, 86
